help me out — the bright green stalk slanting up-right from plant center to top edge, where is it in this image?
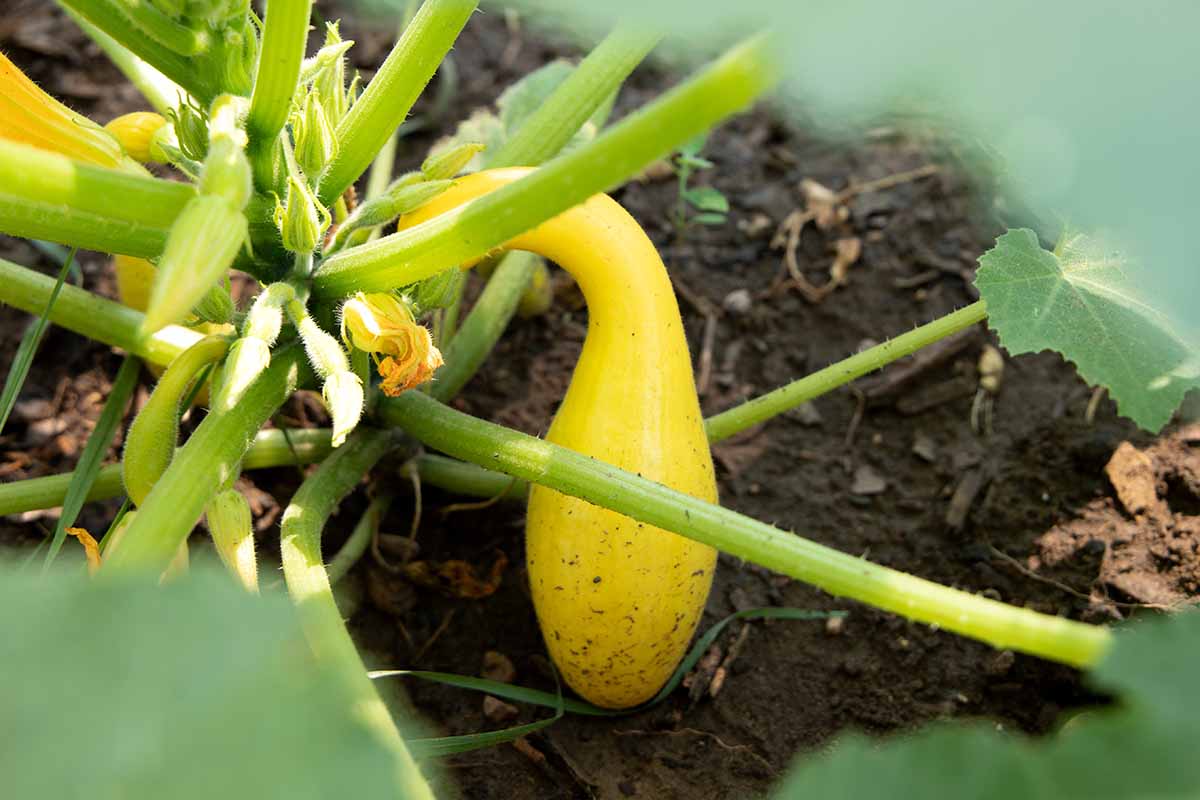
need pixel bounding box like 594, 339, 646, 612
320, 0, 479, 206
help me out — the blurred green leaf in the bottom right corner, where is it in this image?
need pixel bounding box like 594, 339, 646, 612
772, 613, 1200, 800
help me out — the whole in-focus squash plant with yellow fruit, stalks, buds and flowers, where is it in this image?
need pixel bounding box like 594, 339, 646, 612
0, 0, 1194, 798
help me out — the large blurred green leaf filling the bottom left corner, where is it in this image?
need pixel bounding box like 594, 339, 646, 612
0, 567, 400, 800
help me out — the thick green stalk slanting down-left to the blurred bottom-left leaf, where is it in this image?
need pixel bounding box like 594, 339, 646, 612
104, 347, 302, 573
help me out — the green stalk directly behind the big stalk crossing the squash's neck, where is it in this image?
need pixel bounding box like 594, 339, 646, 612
487, 25, 661, 168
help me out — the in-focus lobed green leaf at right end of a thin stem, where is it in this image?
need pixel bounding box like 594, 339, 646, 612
976, 228, 1200, 431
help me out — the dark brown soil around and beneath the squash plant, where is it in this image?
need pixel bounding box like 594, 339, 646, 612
0, 0, 1200, 799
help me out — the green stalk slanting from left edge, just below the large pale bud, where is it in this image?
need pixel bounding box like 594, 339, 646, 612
0, 259, 203, 366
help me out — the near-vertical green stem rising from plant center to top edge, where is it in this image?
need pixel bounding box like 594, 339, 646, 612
246, 0, 312, 188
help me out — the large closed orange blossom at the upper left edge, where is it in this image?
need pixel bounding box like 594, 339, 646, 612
0, 53, 126, 167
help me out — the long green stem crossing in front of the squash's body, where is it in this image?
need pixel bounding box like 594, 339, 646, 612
379, 392, 1111, 667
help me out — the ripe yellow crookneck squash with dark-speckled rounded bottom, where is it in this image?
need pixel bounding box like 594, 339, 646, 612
402, 168, 716, 708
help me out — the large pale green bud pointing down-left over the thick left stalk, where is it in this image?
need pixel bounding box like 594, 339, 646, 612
142, 196, 248, 335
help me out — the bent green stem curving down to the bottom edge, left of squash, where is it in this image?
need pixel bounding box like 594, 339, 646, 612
276, 428, 433, 800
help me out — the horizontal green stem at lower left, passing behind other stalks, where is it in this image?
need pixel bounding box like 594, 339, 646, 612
0, 428, 333, 517
